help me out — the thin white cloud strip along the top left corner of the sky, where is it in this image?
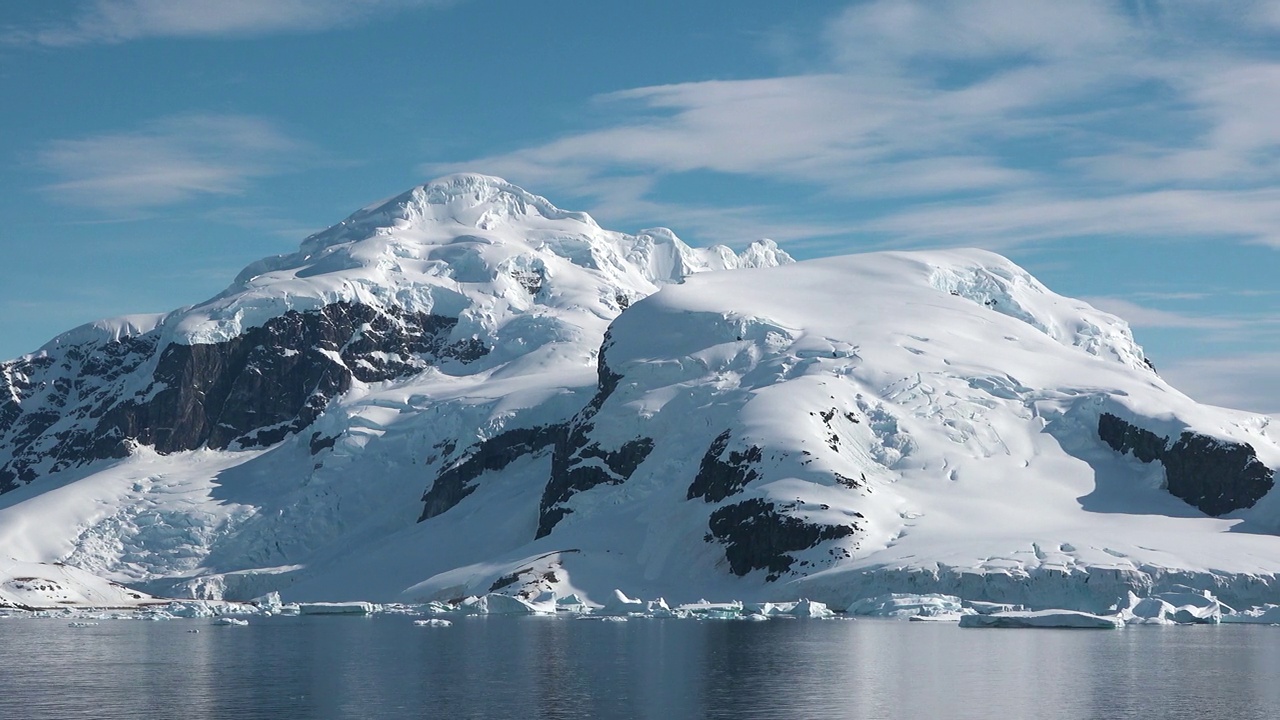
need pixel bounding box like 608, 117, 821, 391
4, 0, 452, 46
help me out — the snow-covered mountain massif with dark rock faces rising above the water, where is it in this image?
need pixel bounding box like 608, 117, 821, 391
0, 176, 1280, 609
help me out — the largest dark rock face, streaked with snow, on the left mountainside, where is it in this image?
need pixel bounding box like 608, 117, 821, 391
0, 302, 486, 492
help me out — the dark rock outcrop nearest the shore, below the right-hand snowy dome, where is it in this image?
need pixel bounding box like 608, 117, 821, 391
708, 498, 859, 582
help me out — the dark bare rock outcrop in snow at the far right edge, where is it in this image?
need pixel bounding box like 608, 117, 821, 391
1098, 413, 1275, 516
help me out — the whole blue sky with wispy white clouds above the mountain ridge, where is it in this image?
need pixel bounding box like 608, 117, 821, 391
0, 0, 1280, 414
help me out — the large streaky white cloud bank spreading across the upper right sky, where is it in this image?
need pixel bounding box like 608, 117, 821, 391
422, 0, 1280, 247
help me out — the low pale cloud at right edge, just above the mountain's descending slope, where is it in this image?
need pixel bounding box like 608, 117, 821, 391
1160, 352, 1280, 418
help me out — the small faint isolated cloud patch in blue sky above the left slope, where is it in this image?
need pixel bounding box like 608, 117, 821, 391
36, 115, 307, 208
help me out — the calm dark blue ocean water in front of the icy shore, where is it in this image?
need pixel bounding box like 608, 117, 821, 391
0, 616, 1280, 720
